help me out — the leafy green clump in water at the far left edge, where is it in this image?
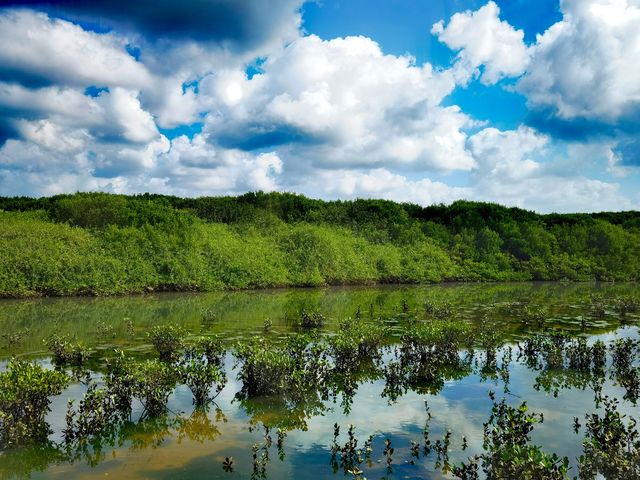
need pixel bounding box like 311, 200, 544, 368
0, 359, 69, 450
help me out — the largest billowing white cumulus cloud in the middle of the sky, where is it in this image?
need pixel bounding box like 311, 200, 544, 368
200, 35, 474, 170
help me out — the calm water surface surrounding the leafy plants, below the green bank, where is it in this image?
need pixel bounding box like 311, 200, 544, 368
0, 283, 640, 479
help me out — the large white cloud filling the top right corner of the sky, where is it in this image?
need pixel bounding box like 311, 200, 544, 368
518, 0, 640, 121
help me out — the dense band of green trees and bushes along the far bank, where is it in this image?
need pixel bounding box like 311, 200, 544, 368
0, 192, 640, 296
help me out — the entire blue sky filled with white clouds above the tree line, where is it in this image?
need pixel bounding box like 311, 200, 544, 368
0, 0, 640, 212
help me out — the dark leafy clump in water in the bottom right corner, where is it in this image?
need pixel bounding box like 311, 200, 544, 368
578, 397, 640, 480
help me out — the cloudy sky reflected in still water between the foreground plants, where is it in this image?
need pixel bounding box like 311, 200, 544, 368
0, 286, 640, 479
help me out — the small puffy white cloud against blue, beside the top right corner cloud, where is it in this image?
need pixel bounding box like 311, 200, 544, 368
431, 1, 529, 84
